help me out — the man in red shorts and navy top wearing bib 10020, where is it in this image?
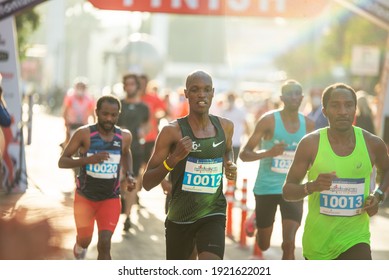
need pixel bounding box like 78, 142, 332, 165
58, 95, 135, 259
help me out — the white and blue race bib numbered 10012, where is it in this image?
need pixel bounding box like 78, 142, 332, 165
182, 157, 223, 194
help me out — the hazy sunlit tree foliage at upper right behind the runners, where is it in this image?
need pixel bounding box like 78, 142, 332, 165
276, 5, 388, 93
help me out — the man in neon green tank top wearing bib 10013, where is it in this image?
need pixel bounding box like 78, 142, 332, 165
283, 83, 389, 260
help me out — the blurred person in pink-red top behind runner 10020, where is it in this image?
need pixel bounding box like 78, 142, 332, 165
61, 77, 95, 148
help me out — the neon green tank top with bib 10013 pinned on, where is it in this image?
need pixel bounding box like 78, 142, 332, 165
302, 127, 373, 260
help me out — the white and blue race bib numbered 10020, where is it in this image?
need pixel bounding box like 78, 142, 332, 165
86, 153, 120, 179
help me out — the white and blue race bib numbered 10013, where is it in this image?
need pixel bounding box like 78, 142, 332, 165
320, 178, 365, 216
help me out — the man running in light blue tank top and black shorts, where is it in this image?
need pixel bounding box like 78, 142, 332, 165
239, 80, 315, 259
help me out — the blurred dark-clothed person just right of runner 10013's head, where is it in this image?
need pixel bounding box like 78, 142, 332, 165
355, 90, 376, 134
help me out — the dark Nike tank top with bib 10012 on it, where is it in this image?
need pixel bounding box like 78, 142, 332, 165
168, 115, 227, 223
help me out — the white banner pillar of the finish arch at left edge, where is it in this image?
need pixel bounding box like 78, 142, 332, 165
0, 16, 27, 193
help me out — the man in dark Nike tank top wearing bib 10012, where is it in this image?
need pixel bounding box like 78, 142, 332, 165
143, 71, 236, 259
